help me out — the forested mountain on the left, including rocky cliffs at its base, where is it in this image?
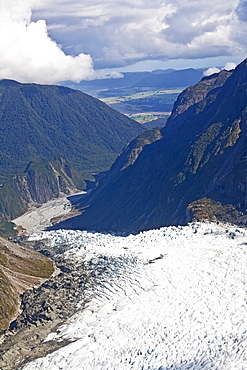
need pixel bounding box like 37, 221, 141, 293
0, 80, 143, 227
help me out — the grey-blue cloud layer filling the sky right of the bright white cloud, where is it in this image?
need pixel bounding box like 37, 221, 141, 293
33, 0, 247, 68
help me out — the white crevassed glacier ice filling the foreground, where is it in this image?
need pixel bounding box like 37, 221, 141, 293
24, 223, 247, 370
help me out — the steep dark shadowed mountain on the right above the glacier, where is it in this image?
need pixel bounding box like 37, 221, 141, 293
56, 60, 247, 232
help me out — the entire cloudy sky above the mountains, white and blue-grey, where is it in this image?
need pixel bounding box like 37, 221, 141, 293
0, 0, 247, 83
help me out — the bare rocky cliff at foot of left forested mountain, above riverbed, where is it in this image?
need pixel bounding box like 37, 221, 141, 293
0, 158, 79, 219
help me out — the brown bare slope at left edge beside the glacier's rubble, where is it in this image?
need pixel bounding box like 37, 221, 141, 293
0, 237, 54, 331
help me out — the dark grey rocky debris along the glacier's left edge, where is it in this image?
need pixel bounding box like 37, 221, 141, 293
0, 237, 114, 370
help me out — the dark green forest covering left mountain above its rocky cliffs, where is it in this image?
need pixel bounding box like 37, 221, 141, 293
0, 80, 141, 177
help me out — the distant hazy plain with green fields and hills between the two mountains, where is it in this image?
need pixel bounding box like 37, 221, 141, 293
65, 68, 203, 128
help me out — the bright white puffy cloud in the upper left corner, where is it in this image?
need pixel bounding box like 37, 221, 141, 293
0, 0, 95, 83
